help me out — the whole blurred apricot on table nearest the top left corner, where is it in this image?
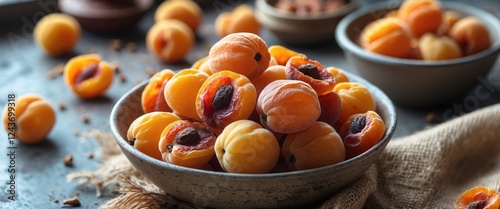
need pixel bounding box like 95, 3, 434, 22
33, 13, 81, 56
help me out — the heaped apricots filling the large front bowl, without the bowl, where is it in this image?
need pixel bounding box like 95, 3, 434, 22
127, 32, 385, 173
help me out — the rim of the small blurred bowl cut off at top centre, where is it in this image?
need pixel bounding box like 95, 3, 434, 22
255, 0, 359, 21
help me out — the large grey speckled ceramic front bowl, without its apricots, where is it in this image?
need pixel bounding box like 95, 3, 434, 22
110, 71, 396, 209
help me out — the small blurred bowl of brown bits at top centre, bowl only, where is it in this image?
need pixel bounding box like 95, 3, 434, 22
255, 0, 359, 44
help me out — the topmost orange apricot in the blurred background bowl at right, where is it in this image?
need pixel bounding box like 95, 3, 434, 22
398, 0, 443, 38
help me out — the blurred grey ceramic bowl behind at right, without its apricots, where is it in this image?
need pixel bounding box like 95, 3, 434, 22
335, 2, 500, 107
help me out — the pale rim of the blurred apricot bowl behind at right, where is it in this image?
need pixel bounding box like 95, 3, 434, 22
335, 1, 500, 66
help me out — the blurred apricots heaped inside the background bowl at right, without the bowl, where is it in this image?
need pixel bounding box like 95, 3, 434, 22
358, 0, 491, 61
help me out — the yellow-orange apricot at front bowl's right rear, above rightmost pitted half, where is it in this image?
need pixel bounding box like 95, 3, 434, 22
333, 82, 375, 124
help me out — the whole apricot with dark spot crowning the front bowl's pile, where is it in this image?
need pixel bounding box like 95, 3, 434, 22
208, 32, 271, 80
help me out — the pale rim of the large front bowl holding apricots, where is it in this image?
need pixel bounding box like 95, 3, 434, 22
109, 72, 397, 180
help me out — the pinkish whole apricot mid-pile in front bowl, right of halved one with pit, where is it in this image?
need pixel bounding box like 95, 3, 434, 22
257, 80, 321, 133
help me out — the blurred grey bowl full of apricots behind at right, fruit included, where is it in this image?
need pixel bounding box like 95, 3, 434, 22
335, 0, 500, 107
